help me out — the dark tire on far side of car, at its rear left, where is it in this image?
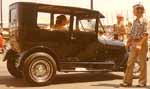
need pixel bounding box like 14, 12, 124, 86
7, 59, 22, 78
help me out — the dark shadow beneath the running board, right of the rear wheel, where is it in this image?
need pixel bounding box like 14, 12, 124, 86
53, 73, 122, 84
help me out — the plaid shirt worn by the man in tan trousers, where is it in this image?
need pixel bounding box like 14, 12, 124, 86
130, 20, 147, 40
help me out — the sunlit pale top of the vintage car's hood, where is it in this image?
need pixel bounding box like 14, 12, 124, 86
98, 35, 125, 46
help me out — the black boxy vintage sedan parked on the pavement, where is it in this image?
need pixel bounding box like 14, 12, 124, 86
4, 2, 128, 85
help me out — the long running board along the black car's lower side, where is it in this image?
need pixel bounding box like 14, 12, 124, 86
60, 61, 115, 72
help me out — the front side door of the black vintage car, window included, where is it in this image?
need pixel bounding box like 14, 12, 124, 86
67, 18, 97, 61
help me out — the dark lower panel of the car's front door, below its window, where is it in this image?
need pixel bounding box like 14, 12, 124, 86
72, 31, 97, 61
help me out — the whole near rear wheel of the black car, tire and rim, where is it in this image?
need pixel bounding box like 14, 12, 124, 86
23, 52, 57, 86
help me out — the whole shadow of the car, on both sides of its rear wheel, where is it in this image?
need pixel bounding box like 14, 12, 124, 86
0, 73, 122, 87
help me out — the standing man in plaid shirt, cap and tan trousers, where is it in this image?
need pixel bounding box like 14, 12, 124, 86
120, 4, 148, 87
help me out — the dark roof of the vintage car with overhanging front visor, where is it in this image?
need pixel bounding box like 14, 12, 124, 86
10, 2, 104, 18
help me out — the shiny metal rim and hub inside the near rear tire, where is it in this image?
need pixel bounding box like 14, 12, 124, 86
30, 59, 53, 82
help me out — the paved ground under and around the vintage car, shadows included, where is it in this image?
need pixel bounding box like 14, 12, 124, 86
0, 55, 150, 89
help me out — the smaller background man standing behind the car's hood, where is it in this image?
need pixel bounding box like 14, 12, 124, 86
113, 15, 126, 41
